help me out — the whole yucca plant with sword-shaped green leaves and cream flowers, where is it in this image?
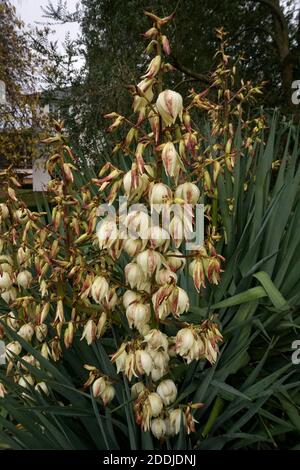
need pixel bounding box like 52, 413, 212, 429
0, 14, 300, 450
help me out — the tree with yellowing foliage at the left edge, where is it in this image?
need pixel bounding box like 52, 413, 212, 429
0, 1, 47, 166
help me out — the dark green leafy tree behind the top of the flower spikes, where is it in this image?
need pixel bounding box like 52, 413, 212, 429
40, 0, 300, 162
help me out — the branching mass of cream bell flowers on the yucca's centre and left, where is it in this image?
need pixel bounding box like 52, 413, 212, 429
0, 13, 230, 439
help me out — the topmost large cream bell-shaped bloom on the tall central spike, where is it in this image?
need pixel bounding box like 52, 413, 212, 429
156, 90, 183, 126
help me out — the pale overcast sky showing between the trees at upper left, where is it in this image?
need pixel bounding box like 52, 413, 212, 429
11, 0, 79, 50
